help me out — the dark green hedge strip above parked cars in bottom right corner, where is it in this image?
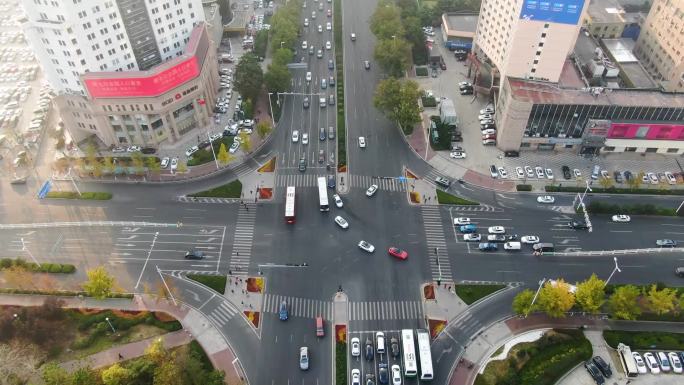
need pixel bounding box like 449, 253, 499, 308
603, 330, 684, 350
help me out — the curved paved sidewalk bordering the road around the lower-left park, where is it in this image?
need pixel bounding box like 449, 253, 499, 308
0, 294, 246, 384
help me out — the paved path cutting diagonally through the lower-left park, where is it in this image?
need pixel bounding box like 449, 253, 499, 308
59, 330, 193, 372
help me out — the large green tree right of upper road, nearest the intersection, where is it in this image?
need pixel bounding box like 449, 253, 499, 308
373, 78, 421, 132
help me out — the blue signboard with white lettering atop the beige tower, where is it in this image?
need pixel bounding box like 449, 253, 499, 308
520, 0, 586, 24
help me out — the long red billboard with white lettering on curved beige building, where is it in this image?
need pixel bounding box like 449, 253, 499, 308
84, 56, 200, 98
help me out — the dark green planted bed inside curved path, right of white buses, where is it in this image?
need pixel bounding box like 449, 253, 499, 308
475, 329, 592, 385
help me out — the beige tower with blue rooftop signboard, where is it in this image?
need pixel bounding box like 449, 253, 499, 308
475, 0, 589, 86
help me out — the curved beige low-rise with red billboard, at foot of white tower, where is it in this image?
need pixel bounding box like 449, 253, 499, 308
55, 22, 218, 146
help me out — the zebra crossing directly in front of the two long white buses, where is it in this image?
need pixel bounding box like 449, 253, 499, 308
349, 301, 423, 321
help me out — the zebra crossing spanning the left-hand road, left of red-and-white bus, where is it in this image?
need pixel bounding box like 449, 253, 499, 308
230, 203, 257, 276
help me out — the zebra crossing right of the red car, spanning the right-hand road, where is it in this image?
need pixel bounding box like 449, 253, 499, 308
420, 206, 453, 281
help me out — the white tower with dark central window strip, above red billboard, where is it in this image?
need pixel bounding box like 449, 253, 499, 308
21, 0, 204, 95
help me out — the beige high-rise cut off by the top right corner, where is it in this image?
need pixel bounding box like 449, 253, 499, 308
634, 0, 684, 92
